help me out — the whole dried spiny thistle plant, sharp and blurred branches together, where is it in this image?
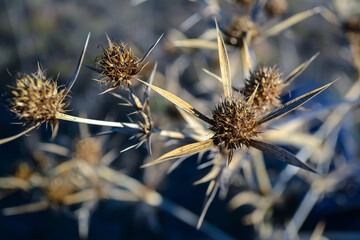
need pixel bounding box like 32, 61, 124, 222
0, 0, 360, 239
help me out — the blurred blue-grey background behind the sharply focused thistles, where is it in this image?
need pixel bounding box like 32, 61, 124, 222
0, 0, 360, 239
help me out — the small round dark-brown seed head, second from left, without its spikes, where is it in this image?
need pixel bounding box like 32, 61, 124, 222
97, 42, 142, 88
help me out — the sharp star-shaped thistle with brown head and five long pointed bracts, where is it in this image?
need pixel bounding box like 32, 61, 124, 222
139, 21, 332, 172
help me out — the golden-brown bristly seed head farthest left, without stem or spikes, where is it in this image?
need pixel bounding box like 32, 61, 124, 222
10, 73, 68, 125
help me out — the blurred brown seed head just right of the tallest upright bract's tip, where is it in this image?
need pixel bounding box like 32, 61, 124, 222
225, 16, 259, 46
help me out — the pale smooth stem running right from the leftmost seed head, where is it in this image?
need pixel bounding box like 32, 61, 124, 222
56, 113, 140, 129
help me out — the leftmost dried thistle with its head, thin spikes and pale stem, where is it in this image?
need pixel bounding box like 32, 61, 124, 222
0, 33, 143, 144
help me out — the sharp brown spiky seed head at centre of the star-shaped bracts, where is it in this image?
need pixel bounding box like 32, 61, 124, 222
210, 99, 260, 150
